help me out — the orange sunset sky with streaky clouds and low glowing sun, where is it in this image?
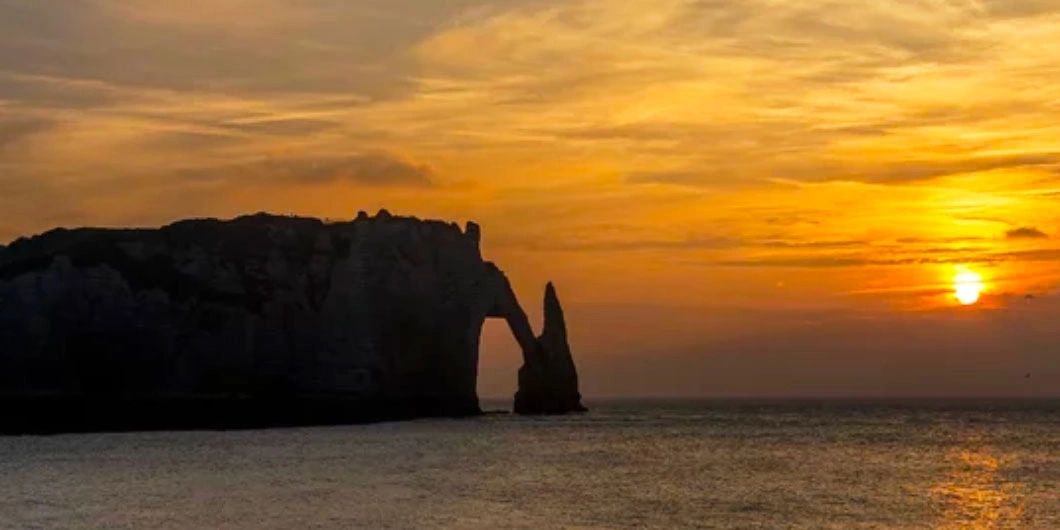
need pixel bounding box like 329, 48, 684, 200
0, 0, 1060, 399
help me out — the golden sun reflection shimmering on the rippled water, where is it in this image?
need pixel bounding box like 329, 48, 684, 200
931, 448, 1024, 529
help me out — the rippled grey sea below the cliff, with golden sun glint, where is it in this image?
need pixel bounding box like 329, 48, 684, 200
0, 401, 1060, 529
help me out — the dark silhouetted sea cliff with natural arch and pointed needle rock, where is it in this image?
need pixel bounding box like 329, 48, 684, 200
0, 211, 582, 431
